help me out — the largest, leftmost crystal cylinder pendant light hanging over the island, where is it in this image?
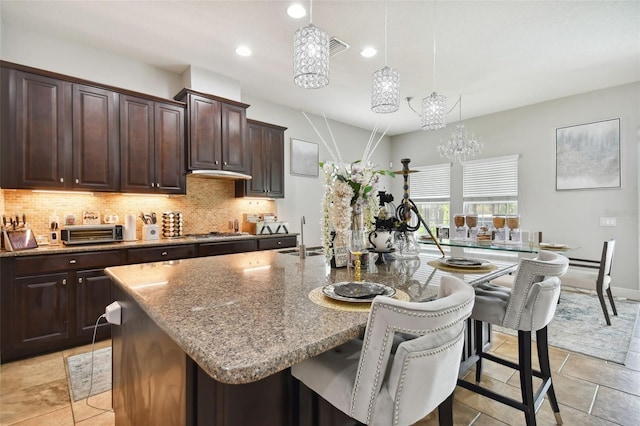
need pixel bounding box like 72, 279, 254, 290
293, 1, 329, 89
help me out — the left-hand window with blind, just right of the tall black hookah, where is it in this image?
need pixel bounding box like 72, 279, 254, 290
409, 163, 451, 234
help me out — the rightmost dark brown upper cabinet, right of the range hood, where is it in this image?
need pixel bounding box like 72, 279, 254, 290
235, 120, 287, 198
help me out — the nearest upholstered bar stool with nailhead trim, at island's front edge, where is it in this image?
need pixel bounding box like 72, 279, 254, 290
291, 276, 474, 426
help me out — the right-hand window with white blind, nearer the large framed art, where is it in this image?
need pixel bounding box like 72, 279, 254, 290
462, 155, 518, 228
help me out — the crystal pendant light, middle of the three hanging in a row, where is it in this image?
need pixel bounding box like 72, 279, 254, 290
371, 1, 400, 114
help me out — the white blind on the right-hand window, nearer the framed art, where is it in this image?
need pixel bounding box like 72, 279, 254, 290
462, 155, 518, 198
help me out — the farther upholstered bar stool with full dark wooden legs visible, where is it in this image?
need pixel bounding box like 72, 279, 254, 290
458, 251, 569, 425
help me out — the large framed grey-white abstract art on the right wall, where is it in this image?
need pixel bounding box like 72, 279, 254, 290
556, 118, 621, 191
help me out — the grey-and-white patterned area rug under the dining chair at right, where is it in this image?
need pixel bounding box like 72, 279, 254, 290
494, 290, 640, 364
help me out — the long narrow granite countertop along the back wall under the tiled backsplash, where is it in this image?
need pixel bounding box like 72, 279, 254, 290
0, 233, 298, 257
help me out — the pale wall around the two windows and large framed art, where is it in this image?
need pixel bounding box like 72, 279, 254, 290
391, 83, 640, 290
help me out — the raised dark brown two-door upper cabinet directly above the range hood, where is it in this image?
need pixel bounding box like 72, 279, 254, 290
175, 89, 250, 173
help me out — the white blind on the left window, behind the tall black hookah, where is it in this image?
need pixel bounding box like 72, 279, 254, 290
409, 163, 451, 200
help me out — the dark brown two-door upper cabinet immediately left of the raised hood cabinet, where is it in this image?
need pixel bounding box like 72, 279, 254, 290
120, 95, 186, 194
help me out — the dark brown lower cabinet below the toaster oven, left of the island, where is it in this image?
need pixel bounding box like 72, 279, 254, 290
0, 250, 120, 362
